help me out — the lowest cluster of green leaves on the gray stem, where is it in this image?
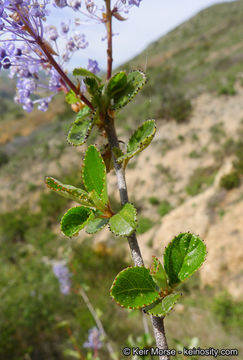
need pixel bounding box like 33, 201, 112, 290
111, 233, 206, 316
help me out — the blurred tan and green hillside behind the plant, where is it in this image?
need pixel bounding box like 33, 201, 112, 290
0, 1, 243, 360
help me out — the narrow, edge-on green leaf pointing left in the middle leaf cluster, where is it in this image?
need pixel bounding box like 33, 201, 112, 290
45, 177, 94, 208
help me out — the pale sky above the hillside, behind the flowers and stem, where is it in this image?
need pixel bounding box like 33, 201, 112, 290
48, 0, 232, 70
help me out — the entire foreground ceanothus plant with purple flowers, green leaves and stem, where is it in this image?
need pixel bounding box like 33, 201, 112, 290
0, 0, 206, 359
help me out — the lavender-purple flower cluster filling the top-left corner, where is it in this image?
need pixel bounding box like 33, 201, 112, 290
0, 0, 88, 112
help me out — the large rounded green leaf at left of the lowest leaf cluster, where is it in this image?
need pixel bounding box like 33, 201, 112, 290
110, 266, 159, 309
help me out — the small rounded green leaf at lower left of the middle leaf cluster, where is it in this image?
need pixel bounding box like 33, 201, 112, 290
61, 206, 94, 237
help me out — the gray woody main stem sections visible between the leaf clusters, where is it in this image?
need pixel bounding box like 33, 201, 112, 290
105, 115, 170, 360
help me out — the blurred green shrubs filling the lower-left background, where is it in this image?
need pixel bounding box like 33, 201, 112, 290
0, 201, 135, 360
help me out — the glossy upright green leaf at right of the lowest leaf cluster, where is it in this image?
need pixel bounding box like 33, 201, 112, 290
164, 233, 206, 287
